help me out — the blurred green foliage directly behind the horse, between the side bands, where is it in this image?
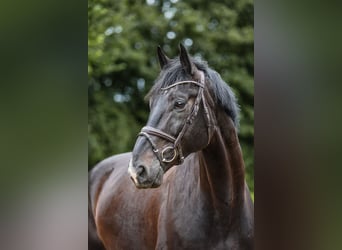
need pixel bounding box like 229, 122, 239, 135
88, 0, 254, 191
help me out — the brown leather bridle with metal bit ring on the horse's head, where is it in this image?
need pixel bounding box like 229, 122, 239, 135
138, 71, 212, 168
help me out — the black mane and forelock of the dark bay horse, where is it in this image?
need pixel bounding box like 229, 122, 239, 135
146, 57, 239, 127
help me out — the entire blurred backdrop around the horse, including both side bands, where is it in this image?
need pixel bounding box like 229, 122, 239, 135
0, 0, 342, 250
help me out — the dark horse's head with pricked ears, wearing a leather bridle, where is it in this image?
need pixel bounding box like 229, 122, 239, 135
128, 45, 213, 188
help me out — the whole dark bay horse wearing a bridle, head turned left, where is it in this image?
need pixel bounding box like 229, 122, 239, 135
88, 45, 254, 250
